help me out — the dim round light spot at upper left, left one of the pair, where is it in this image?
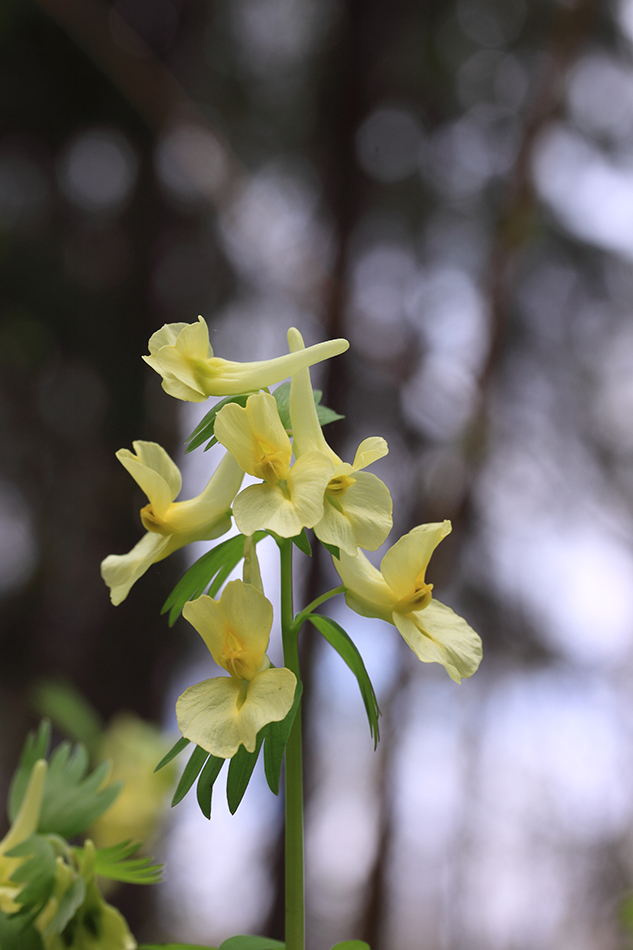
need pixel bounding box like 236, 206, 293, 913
59, 130, 138, 212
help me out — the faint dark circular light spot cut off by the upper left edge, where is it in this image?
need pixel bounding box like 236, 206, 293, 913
0, 151, 50, 231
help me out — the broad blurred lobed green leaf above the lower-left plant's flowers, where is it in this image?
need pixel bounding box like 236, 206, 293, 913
37, 742, 122, 838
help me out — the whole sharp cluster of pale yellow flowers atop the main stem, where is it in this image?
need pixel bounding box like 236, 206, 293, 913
102, 318, 481, 758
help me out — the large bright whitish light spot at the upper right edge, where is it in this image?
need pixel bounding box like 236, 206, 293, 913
534, 124, 633, 257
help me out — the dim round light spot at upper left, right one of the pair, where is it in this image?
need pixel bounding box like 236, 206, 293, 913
156, 123, 229, 201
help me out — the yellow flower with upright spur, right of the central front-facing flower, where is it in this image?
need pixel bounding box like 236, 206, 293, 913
288, 327, 393, 555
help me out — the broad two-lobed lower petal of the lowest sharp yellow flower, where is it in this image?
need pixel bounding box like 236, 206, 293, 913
176, 669, 296, 758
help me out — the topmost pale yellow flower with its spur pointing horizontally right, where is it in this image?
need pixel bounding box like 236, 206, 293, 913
143, 317, 349, 402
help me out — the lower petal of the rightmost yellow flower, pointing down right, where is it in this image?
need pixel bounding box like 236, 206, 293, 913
393, 600, 482, 683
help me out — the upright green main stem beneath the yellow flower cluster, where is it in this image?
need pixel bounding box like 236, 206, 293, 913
280, 540, 305, 950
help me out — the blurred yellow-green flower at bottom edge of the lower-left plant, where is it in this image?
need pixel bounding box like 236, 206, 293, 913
35, 840, 138, 950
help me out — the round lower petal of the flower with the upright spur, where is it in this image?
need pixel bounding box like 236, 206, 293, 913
314, 472, 393, 556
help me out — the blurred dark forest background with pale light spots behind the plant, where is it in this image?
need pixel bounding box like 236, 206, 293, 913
0, 0, 633, 950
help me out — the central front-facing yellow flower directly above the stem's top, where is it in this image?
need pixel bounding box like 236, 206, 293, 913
214, 393, 334, 538
